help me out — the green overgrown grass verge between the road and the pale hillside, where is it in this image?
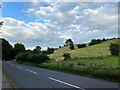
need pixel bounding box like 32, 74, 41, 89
17, 57, 120, 82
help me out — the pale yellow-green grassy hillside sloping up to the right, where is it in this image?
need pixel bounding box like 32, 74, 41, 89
49, 39, 118, 60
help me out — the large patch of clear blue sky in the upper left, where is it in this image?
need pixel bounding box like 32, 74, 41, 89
2, 2, 46, 23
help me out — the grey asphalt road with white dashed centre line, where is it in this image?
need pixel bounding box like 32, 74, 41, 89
3, 61, 118, 90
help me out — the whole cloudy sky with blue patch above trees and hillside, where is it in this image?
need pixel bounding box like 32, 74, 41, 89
0, 0, 118, 50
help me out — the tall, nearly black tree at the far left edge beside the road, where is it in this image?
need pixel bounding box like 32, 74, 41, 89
2, 38, 13, 60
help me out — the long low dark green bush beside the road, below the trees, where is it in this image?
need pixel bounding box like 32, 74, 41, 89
16, 52, 50, 63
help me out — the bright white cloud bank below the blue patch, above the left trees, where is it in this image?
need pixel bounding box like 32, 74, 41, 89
2, 18, 62, 48
